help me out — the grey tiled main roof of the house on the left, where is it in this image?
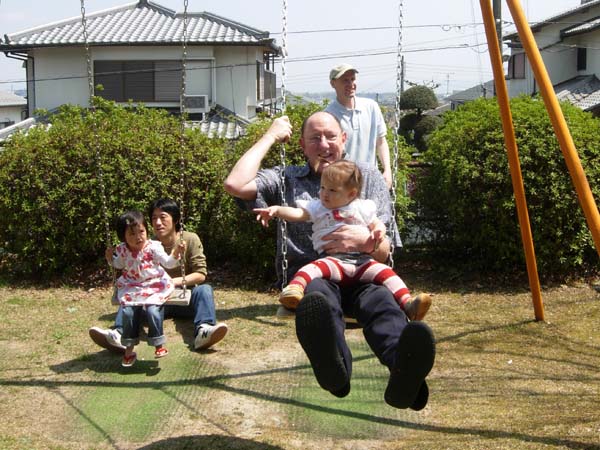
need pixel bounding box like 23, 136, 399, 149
0, 0, 279, 51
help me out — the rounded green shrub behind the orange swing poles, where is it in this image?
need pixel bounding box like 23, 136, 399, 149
417, 97, 600, 277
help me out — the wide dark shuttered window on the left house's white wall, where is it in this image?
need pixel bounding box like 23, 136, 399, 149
94, 61, 181, 102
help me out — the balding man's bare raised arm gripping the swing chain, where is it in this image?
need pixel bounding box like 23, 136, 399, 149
224, 116, 292, 200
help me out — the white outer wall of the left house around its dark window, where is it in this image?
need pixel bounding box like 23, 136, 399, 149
29, 46, 262, 118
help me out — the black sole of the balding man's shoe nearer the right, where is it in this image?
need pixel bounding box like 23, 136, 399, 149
384, 322, 435, 409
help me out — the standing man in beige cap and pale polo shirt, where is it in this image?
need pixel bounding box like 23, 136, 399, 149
325, 64, 392, 189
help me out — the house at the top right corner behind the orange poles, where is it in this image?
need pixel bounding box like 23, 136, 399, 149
503, 0, 600, 115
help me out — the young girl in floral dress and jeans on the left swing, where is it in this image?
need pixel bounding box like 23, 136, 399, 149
105, 210, 185, 367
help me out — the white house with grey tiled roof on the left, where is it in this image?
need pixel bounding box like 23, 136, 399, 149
0, 0, 280, 137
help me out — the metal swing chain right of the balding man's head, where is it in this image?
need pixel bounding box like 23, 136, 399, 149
389, 0, 404, 268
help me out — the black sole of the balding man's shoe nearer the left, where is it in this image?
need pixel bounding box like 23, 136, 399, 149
296, 293, 350, 392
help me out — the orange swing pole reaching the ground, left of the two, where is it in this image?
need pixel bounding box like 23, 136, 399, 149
479, 0, 544, 321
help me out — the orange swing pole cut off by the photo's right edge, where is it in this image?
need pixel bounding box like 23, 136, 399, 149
506, 0, 600, 255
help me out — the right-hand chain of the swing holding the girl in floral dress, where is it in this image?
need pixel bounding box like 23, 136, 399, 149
179, 0, 188, 298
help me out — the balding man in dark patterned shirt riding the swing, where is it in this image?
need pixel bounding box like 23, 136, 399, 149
225, 112, 435, 410
